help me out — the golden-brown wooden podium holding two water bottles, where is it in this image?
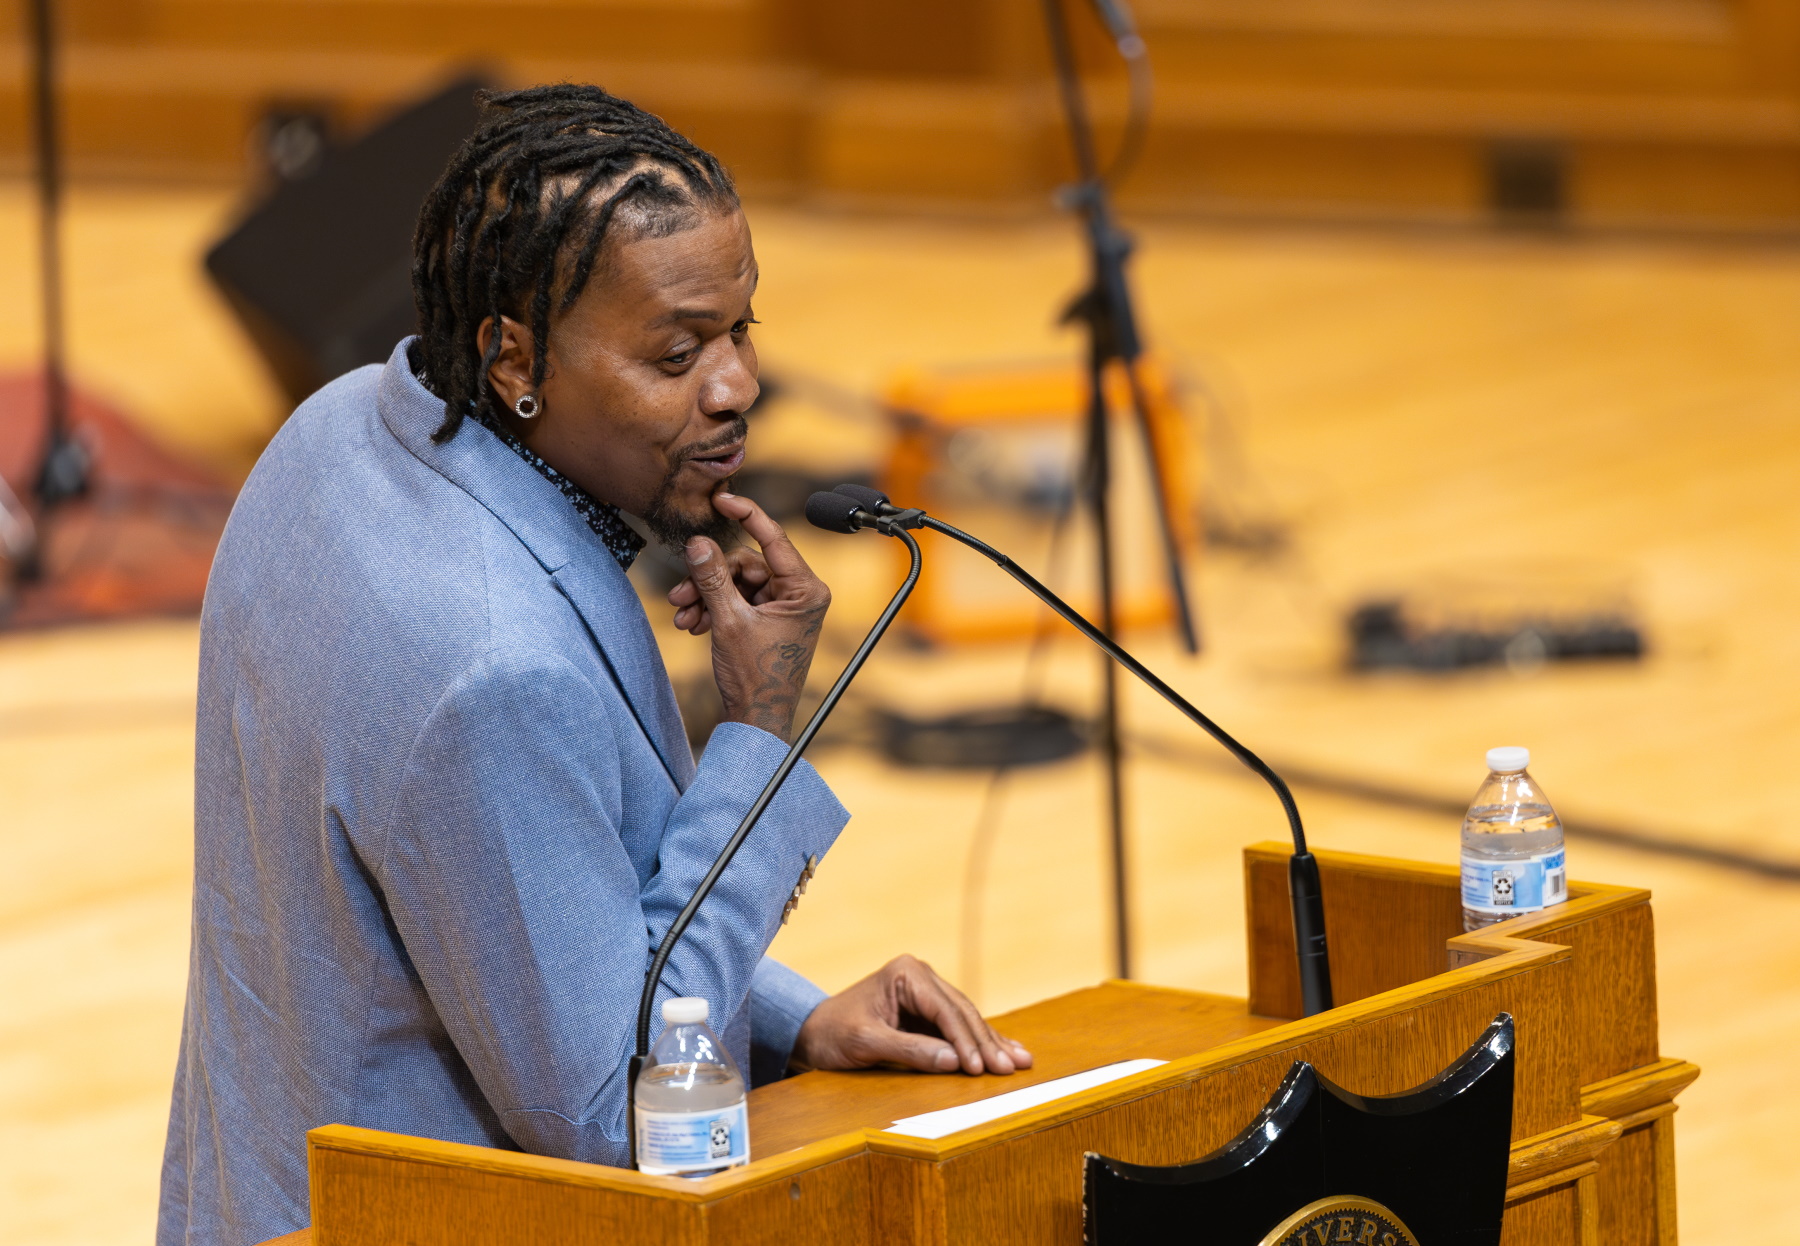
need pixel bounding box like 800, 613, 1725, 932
283, 844, 1699, 1246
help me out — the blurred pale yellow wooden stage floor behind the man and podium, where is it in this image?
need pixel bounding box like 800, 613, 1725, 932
0, 187, 1800, 1246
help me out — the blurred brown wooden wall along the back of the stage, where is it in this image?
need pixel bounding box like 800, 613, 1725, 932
0, 0, 1800, 229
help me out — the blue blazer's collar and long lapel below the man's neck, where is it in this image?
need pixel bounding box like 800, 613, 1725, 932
376, 339, 695, 790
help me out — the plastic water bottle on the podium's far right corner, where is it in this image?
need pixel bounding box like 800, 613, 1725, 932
1462, 749, 1570, 931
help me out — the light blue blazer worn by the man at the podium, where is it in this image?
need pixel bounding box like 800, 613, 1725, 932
157, 342, 848, 1246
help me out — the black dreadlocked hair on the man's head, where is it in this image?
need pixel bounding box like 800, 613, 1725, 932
412, 85, 738, 441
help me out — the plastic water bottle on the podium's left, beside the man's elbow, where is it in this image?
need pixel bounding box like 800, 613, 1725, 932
635, 999, 751, 1178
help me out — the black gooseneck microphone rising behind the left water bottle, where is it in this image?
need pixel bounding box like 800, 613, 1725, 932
625, 493, 920, 1169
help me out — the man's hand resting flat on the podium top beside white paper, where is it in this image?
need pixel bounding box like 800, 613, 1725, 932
794, 956, 1031, 1073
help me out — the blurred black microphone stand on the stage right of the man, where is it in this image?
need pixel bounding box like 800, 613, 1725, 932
1044, 0, 1201, 978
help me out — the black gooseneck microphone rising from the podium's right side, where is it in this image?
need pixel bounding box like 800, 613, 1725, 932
828, 484, 1332, 1017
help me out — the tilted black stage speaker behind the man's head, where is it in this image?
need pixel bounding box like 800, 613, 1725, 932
207, 77, 484, 403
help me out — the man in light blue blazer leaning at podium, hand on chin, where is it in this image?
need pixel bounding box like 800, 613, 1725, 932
158, 86, 1030, 1246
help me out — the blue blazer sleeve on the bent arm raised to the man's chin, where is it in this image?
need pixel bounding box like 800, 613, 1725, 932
376, 654, 848, 1165
